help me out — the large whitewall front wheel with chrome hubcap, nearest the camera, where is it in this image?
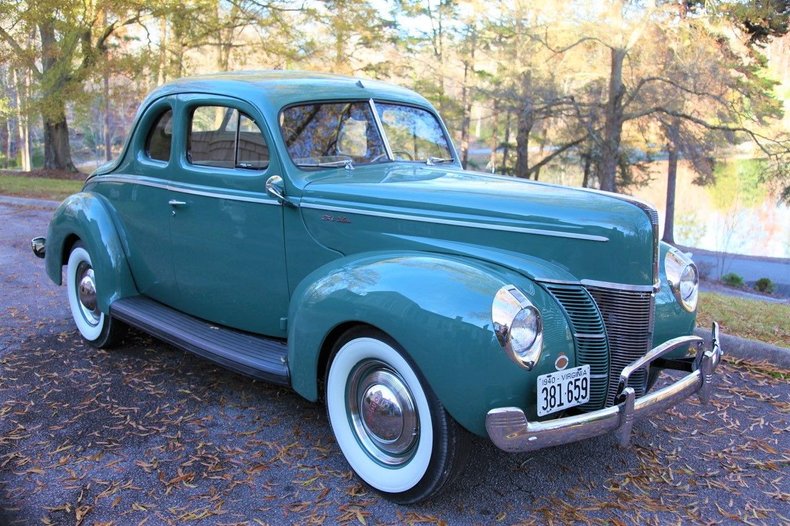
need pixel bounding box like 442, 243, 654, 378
326, 329, 469, 504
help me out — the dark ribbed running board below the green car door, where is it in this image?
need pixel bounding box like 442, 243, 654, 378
110, 296, 291, 386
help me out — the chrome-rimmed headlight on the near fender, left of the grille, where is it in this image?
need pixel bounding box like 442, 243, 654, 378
491, 285, 543, 371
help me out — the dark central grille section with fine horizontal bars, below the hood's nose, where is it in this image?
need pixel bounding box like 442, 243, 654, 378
586, 285, 654, 406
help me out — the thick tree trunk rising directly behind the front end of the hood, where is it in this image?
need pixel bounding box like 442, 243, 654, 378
598, 48, 626, 192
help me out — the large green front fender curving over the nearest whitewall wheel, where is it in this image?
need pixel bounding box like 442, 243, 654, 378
288, 252, 575, 435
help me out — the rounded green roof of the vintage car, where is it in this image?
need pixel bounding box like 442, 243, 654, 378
148, 70, 430, 112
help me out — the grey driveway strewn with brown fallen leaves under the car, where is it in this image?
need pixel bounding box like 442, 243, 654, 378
0, 201, 790, 525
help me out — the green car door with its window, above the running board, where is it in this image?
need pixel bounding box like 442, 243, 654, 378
170, 95, 288, 337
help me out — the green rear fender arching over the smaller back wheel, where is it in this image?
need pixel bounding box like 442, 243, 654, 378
45, 192, 137, 314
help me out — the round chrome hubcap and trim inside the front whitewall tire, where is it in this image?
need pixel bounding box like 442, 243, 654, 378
346, 360, 419, 466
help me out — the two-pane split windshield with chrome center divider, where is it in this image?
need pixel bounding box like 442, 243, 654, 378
280, 101, 453, 168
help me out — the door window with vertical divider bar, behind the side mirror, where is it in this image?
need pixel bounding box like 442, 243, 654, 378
187, 106, 269, 169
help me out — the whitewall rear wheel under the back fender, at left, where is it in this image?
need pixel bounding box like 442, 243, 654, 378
66, 241, 126, 348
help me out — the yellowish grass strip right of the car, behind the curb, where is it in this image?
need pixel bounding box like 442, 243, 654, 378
697, 292, 790, 347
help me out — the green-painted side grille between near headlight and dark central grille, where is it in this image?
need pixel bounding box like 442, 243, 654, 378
543, 283, 609, 411
